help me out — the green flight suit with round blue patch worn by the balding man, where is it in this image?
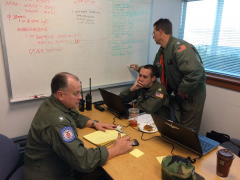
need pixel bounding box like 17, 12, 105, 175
24, 96, 109, 180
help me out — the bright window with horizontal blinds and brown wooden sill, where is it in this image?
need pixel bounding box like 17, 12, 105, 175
179, 0, 240, 91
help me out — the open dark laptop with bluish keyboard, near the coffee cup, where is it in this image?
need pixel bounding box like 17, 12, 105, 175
151, 114, 220, 156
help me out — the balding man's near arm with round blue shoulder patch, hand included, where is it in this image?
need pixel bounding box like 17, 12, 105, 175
45, 121, 132, 172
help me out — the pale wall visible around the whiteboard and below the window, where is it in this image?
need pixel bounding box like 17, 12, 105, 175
0, 0, 240, 138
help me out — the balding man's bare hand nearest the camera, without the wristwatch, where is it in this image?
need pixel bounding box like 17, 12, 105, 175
108, 133, 133, 159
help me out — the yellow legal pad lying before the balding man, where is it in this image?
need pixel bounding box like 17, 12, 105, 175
83, 130, 126, 146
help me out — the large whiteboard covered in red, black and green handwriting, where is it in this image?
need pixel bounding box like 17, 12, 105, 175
1, 0, 151, 102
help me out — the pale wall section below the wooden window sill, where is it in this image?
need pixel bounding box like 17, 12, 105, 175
200, 85, 240, 139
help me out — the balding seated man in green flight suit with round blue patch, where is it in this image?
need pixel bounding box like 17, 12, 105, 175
23, 72, 132, 180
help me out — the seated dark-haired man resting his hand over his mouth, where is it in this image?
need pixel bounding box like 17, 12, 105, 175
120, 64, 169, 119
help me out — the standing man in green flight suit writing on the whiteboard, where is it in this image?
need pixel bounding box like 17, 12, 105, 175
130, 19, 206, 132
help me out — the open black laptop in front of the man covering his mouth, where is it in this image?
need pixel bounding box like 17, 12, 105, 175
99, 88, 128, 119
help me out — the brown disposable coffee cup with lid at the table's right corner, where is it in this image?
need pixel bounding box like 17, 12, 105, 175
217, 149, 234, 177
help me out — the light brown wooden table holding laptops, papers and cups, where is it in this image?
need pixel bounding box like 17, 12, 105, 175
78, 107, 240, 180
